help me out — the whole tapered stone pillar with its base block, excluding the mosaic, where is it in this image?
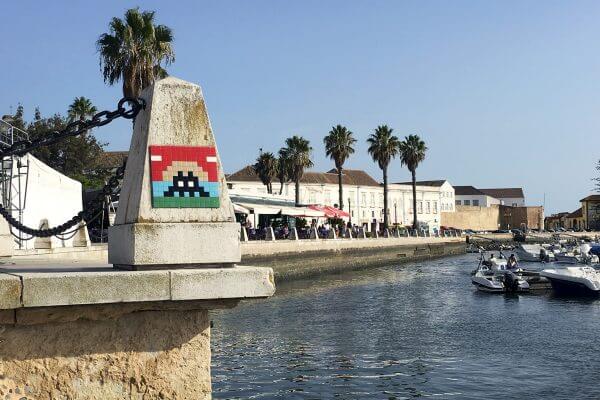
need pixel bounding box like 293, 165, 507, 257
108, 77, 240, 269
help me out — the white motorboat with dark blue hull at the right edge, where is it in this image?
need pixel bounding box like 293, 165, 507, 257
540, 266, 600, 296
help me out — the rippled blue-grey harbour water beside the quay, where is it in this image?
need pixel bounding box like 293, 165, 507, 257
211, 254, 600, 399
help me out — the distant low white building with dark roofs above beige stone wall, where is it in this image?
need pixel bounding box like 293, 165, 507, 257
454, 186, 525, 207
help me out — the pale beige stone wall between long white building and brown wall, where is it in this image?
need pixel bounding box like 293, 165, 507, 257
441, 205, 500, 231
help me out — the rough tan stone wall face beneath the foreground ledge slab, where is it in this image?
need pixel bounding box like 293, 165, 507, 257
0, 310, 211, 400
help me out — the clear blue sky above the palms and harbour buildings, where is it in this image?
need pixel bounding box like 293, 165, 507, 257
0, 0, 600, 213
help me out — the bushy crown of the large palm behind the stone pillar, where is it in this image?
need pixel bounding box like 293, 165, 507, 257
96, 8, 175, 97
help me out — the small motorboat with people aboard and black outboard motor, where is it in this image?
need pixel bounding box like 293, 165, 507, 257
471, 253, 529, 293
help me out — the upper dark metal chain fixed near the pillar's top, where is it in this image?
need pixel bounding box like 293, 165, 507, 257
0, 97, 146, 158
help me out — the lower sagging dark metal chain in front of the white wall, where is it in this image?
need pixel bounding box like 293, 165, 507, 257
0, 161, 126, 237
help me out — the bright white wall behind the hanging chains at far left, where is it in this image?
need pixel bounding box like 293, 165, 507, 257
12, 154, 83, 249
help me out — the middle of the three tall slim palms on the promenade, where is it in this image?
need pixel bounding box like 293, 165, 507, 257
367, 125, 400, 229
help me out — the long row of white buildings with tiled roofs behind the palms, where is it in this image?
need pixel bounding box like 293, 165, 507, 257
227, 166, 454, 229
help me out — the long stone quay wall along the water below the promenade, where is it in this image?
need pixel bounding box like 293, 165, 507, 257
242, 237, 466, 282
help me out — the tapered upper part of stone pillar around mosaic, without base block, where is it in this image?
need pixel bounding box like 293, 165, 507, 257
115, 77, 235, 225
